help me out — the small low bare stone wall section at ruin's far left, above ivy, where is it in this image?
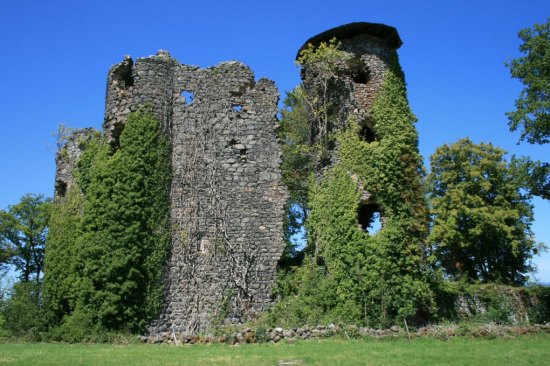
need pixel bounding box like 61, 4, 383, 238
54, 128, 97, 200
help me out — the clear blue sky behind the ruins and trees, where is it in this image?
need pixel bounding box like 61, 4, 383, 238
0, 0, 550, 282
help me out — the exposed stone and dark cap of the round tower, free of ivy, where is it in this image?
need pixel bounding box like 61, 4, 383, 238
296, 22, 402, 229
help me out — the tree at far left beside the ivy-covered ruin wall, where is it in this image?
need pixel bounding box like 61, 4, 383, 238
0, 193, 50, 282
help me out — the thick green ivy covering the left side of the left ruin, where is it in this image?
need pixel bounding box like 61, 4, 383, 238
47, 112, 171, 331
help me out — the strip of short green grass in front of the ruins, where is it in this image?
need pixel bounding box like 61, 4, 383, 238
0, 334, 550, 366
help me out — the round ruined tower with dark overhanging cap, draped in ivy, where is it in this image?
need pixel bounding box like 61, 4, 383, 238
298, 23, 432, 324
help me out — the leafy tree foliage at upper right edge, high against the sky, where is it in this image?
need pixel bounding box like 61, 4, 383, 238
506, 18, 550, 144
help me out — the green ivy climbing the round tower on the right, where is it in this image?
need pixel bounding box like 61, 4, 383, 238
271, 42, 433, 325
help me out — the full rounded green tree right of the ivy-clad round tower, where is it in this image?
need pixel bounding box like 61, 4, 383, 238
428, 139, 543, 285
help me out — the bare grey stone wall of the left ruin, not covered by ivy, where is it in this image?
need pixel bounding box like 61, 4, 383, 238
58, 50, 287, 336
